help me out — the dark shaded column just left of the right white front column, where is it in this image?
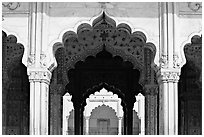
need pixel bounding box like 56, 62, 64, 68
145, 85, 158, 135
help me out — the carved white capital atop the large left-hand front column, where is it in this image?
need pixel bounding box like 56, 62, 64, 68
27, 68, 52, 84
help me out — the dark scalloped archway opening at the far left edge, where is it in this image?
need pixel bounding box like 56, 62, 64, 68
2, 31, 30, 135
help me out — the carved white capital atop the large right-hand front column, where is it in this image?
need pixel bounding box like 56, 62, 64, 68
157, 68, 181, 83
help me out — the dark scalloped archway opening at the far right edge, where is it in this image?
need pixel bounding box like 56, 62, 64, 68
178, 35, 202, 135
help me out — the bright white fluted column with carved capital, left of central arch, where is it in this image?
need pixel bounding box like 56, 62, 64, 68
28, 69, 51, 135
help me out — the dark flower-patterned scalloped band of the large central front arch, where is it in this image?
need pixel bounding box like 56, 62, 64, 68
53, 12, 156, 85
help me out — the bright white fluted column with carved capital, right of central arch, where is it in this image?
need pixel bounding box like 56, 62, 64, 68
157, 69, 180, 135
